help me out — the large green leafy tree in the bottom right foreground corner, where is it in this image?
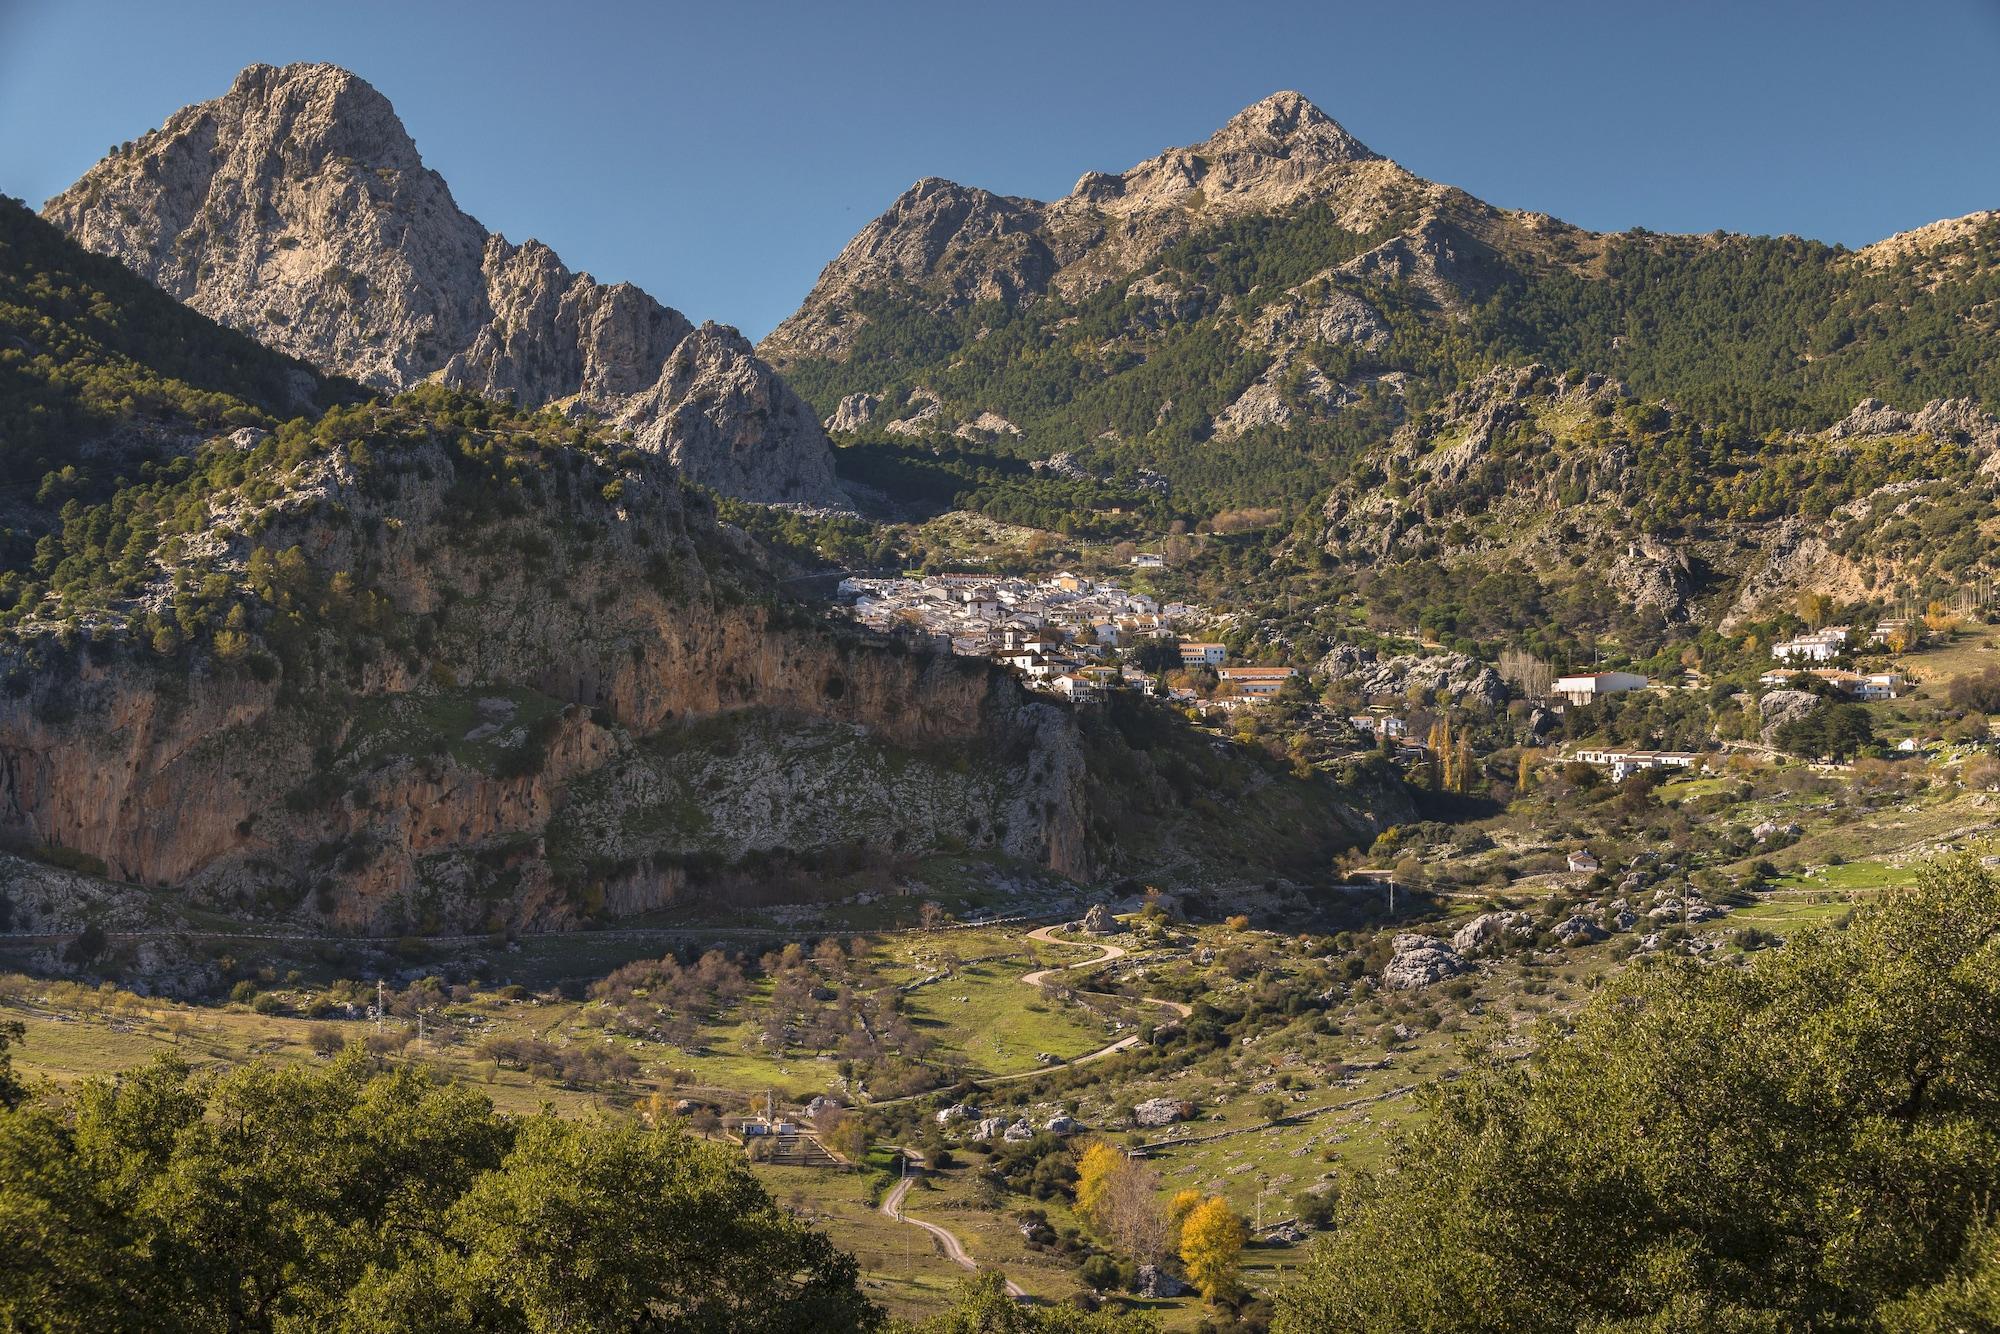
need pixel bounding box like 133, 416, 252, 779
1276, 860, 2000, 1334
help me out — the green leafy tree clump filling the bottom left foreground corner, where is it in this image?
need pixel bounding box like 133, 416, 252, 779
0, 1048, 878, 1334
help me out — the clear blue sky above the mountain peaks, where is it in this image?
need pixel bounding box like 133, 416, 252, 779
0, 0, 2000, 336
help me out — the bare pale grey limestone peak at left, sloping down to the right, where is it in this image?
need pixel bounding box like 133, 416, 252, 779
44, 64, 846, 506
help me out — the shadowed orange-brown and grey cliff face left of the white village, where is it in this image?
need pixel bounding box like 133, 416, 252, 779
0, 412, 1092, 930
